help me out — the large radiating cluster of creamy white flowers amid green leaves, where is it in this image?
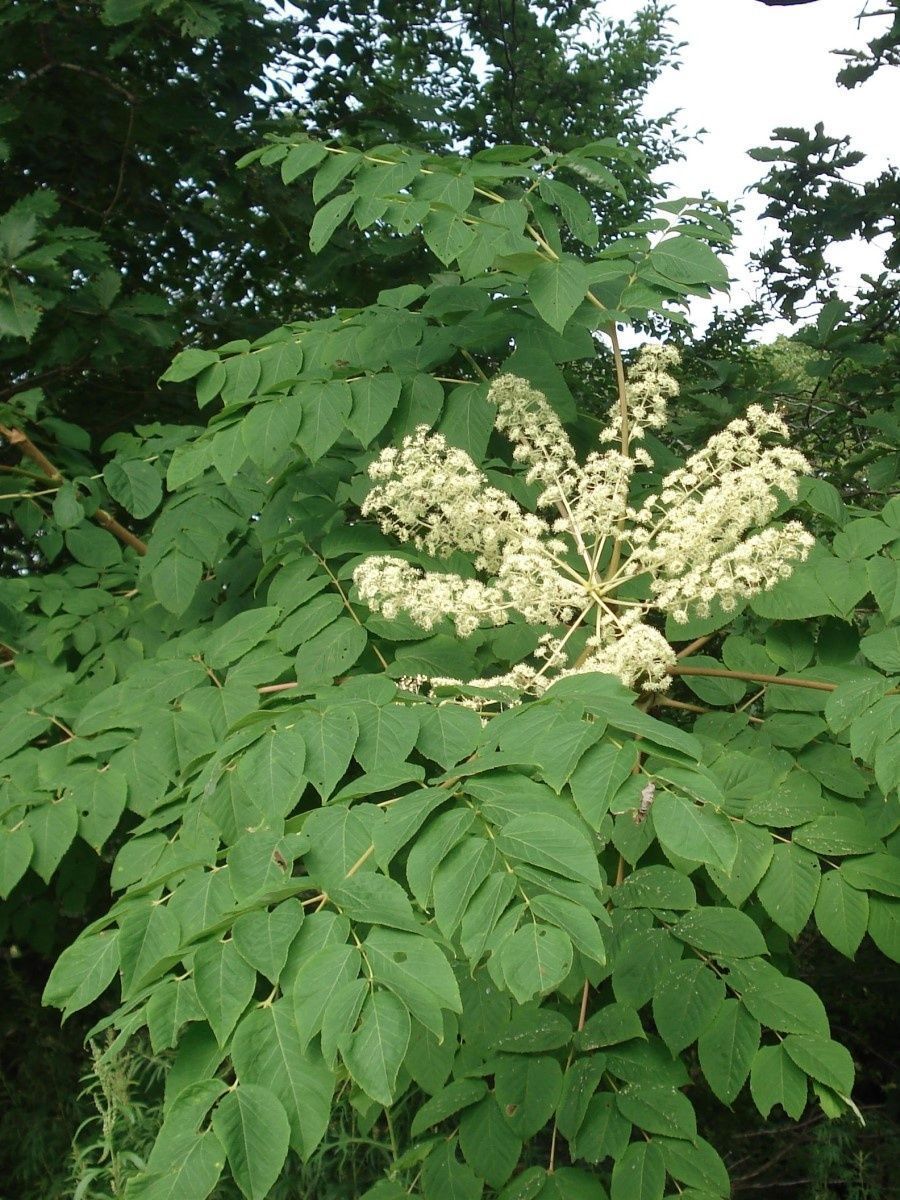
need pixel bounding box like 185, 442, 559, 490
354, 347, 812, 694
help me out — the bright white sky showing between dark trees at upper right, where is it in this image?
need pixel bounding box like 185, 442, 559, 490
601, 0, 900, 337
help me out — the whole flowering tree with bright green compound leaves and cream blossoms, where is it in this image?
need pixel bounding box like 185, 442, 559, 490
0, 126, 900, 1200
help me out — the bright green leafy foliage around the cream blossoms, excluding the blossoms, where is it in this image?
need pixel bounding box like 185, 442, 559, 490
0, 4, 900, 1200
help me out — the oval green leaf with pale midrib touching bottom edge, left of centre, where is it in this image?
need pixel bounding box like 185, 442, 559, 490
212, 1084, 290, 1200
